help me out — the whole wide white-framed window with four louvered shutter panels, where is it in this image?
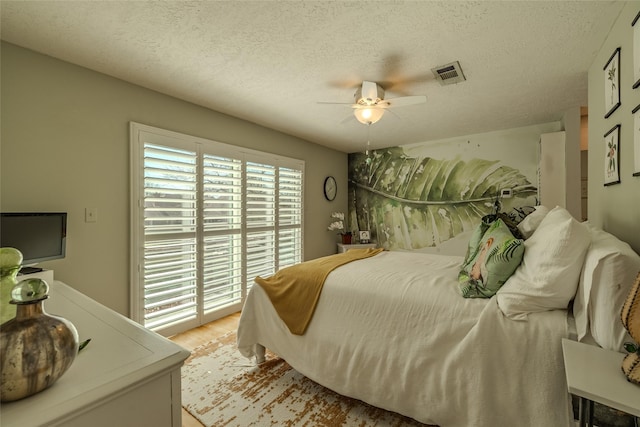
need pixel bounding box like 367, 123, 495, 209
131, 123, 304, 335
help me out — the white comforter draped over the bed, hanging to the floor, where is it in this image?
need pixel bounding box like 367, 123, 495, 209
238, 252, 570, 427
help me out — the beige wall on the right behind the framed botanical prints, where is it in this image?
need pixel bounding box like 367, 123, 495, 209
588, 2, 640, 252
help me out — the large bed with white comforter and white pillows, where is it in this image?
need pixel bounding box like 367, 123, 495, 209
238, 208, 640, 427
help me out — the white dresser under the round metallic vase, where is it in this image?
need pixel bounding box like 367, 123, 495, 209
0, 281, 189, 427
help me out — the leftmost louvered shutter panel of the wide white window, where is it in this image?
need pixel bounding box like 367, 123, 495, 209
143, 144, 197, 329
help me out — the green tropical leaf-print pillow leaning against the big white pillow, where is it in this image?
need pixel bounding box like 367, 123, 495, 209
458, 219, 524, 298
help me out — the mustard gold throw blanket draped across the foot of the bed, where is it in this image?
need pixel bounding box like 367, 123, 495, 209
256, 248, 382, 335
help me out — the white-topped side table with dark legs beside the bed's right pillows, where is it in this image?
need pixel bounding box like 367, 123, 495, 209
562, 339, 640, 426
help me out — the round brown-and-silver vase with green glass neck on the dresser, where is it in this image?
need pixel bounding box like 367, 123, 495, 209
0, 279, 79, 402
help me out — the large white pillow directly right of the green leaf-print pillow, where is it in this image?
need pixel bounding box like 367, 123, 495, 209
496, 206, 591, 319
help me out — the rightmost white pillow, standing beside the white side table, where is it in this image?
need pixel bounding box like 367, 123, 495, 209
573, 224, 640, 352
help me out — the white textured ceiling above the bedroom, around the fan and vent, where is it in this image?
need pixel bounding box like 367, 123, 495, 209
0, 0, 624, 152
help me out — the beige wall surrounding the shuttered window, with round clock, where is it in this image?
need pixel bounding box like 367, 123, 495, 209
0, 43, 347, 315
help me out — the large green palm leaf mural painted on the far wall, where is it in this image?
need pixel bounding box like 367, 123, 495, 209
349, 147, 538, 250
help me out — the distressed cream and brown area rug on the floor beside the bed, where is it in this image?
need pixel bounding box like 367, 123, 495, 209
182, 333, 436, 427
